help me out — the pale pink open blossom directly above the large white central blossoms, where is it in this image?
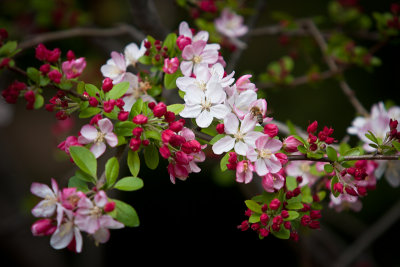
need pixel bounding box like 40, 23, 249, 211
180, 40, 219, 76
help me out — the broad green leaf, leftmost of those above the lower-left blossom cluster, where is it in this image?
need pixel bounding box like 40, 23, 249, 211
69, 146, 97, 180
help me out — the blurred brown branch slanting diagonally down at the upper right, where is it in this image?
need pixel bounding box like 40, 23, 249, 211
303, 19, 368, 116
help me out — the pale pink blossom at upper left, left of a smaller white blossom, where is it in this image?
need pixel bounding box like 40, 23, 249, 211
100, 51, 126, 84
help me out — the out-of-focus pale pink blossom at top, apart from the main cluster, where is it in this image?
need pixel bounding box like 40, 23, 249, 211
215, 8, 249, 38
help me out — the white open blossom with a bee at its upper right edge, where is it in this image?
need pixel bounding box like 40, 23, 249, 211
212, 113, 264, 156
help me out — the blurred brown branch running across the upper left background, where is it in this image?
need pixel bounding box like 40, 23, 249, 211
18, 24, 145, 49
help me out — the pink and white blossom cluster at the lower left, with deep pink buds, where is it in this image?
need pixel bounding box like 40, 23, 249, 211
31, 179, 124, 253
